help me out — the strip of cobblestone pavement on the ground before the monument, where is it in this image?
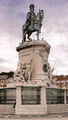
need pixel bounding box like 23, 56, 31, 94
0, 113, 68, 120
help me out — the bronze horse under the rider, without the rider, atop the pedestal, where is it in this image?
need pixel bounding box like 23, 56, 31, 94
23, 9, 44, 42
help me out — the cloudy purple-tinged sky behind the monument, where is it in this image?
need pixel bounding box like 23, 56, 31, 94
0, 0, 68, 75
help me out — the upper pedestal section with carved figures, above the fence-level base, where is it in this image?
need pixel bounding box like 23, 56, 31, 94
15, 40, 50, 85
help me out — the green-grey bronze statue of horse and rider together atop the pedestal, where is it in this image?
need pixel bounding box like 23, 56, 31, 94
22, 4, 44, 43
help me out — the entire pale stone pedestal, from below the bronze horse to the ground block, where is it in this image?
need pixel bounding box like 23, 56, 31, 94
14, 40, 50, 114
